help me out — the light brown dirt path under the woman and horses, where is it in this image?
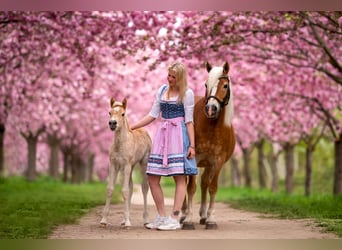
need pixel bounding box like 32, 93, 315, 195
49, 187, 338, 239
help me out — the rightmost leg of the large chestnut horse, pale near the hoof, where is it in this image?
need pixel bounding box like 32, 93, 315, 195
205, 168, 221, 229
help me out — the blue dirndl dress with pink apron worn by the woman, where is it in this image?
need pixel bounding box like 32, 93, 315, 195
146, 84, 197, 176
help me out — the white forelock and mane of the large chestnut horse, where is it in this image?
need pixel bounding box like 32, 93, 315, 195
207, 67, 234, 126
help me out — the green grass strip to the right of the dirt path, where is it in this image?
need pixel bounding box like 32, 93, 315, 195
216, 187, 342, 237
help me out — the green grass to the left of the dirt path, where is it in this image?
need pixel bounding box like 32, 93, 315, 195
0, 177, 118, 239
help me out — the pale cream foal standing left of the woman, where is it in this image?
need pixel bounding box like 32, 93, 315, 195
100, 98, 152, 227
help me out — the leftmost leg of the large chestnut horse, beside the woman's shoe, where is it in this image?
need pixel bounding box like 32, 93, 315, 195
182, 175, 197, 229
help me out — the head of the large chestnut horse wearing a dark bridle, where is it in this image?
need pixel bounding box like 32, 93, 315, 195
205, 62, 231, 119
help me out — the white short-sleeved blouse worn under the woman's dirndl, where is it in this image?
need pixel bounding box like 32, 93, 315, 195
149, 85, 195, 123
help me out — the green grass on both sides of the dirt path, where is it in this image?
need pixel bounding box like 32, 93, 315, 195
0, 173, 342, 239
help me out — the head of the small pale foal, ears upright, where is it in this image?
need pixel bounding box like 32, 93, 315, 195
108, 97, 127, 131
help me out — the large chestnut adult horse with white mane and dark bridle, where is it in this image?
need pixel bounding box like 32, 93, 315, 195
182, 62, 235, 229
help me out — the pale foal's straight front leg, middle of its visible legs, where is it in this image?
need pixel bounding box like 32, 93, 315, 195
121, 164, 133, 227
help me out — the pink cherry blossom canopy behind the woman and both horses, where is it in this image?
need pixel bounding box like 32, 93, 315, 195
0, 11, 342, 194
